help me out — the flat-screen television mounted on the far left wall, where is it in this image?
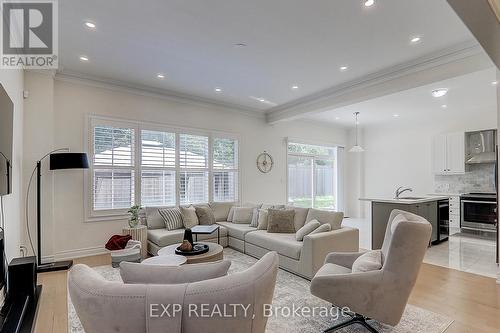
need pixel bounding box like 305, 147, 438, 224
0, 84, 14, 196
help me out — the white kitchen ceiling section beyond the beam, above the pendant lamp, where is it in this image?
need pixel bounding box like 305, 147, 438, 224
307, 68, 497, 127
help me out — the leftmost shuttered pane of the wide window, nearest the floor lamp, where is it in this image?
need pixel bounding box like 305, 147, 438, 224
92, 126, 135, 210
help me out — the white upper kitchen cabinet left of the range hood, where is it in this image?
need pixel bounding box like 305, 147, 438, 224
433, 132, 465, 175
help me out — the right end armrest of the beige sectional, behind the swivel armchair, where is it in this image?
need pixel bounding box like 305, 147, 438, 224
300, 227, 359, 278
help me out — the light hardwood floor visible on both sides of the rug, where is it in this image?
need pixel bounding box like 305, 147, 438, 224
35, 255, 500, 333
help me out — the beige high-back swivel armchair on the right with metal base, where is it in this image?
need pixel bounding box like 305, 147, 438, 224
311, 210, 432, 332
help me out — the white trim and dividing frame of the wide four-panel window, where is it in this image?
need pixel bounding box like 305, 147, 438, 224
84, 114, 242, 222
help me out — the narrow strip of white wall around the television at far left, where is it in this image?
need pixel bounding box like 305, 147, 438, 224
0, 69, 24, 262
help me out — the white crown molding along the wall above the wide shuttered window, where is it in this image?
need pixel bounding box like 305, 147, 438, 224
55, 71, 265, 119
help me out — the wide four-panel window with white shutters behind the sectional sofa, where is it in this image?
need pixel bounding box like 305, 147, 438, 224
89, 117, 239, 217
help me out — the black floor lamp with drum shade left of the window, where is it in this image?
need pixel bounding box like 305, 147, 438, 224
28, 148, 89, 273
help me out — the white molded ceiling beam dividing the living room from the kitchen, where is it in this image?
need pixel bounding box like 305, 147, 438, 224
266, 41, 492, 123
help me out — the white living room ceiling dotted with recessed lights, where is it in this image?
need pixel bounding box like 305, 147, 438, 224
59, 0, 473, 111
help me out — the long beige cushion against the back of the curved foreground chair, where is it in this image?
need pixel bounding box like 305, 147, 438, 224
120, 260, 231, 284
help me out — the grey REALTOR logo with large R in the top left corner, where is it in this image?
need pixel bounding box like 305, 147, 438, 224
0, 0, 58, 69
